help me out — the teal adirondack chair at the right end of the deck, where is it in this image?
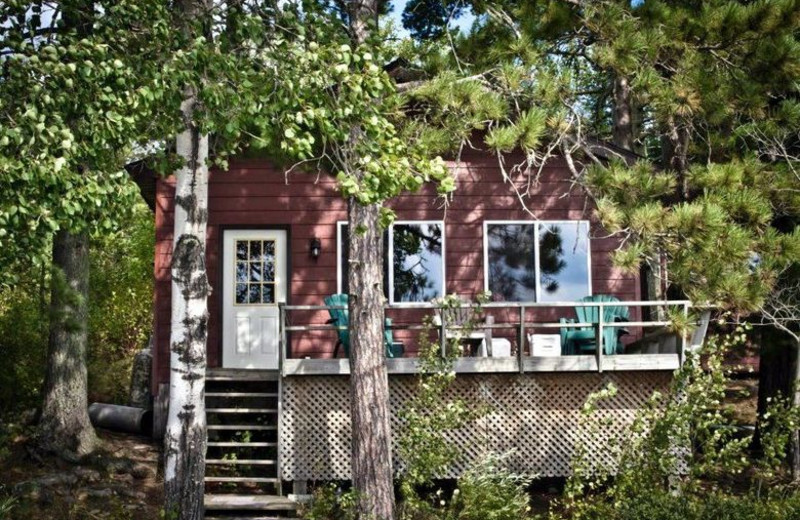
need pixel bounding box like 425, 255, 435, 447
560, 294, 630, 356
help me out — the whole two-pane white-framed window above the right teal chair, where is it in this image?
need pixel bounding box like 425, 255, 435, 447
484, 220, 592, 302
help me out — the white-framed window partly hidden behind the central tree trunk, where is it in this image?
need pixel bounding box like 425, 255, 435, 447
337, 221, 444, 303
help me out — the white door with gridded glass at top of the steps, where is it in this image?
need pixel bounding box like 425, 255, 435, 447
222, 229, 287, 370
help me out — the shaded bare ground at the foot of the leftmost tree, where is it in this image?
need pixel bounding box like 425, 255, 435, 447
0, 425, 163, 520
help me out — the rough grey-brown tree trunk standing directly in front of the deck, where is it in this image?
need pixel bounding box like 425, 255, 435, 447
348, 0, 394, 520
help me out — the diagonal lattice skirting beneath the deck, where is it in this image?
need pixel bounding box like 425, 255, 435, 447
280, 371, 672, 480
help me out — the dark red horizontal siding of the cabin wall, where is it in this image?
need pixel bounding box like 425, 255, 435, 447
153, 153, 640, 388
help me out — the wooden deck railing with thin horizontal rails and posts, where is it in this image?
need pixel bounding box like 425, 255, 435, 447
279, 300, 707, 373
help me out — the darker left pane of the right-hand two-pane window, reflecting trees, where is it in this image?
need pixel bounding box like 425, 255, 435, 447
487, 224, 536, 302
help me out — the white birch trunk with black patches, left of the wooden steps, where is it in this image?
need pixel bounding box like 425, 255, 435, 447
164, 90, 211, 520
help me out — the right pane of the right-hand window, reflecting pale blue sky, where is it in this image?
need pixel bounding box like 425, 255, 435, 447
539, 222, 590, 302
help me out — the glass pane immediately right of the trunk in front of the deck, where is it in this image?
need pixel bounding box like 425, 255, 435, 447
393, 224, 444, 302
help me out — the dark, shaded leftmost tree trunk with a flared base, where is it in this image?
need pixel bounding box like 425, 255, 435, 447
37, 231, 97, 461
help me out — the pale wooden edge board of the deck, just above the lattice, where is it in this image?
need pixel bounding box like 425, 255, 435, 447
282, 354, 680, 377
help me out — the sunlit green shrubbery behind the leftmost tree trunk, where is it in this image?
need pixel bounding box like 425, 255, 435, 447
0, 199, 154, 414
